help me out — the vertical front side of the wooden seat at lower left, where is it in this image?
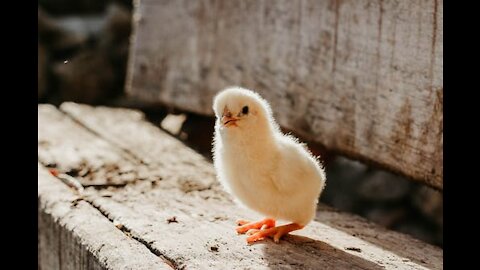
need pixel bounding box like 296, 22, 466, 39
38, 164, 171, 270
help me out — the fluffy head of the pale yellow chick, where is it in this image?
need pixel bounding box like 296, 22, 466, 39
213, 87, 271, 130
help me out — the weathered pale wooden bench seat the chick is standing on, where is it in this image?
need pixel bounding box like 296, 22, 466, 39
38, 103, 443, 269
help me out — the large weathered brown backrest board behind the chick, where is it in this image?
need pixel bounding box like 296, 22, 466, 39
127, 0, 443, 189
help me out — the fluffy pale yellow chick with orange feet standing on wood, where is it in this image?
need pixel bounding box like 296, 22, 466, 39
213, 87, 326, 244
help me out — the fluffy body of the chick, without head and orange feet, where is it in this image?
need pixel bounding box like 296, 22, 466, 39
215, 133, 325, 225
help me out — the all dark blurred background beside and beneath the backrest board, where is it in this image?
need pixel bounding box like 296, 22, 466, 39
38, 0, 443, 247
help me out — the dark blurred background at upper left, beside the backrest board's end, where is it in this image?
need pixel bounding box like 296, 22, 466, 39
38, 0, 132, 104
